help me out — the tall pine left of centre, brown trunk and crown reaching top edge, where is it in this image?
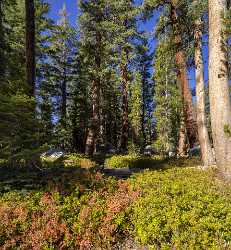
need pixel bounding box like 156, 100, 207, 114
79, 1, 107, 155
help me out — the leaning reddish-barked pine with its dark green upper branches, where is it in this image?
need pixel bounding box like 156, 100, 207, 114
144, 0, 197, 154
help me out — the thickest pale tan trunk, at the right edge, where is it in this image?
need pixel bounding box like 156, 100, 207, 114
209, 0, 231, 172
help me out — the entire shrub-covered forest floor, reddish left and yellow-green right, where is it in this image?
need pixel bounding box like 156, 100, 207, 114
0, 156, 231, 249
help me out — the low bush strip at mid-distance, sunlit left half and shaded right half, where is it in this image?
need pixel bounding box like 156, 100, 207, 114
104, 155, 160, 169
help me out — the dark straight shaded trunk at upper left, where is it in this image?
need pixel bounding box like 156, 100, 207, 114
25, 0, 35, 96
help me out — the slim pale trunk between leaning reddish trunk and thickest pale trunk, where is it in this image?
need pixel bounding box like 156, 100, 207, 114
195, 20, 215, 166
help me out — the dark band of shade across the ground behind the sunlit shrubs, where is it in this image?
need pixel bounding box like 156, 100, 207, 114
0, 158, 200, 194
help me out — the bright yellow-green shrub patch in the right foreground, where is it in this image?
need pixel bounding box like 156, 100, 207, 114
130, 168, 231, 249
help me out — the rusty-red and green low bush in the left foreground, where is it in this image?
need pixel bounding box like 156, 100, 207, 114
0, 171, 139, 250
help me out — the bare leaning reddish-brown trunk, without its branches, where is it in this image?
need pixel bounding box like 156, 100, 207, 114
171, 1, 198, 148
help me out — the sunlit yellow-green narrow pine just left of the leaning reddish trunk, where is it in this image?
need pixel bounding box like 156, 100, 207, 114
154, 39, 182, 155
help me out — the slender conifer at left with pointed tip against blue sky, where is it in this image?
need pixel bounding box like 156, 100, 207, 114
44, 5, 77, 148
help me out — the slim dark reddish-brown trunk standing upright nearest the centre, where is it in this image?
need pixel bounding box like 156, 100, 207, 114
120, 55, 129, 152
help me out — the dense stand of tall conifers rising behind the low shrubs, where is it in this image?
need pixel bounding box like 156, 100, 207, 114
0, 0, 230, 172
